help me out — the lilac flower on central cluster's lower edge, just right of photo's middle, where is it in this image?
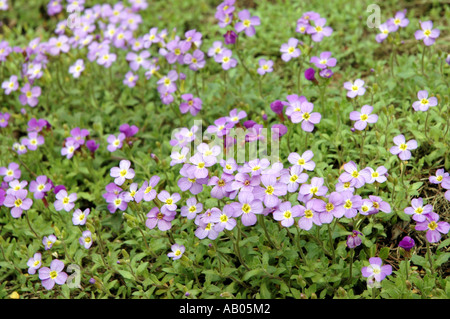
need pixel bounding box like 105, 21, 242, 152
231, 191, 263, 226
